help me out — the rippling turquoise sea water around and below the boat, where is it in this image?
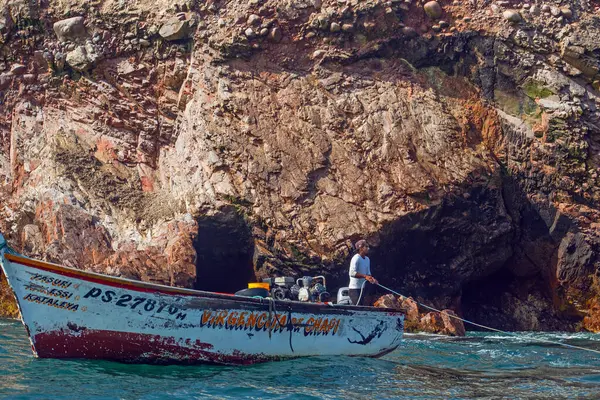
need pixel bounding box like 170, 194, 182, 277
0, 320, 600, 399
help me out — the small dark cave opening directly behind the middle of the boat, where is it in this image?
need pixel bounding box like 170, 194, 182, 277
194, 207, 255, 293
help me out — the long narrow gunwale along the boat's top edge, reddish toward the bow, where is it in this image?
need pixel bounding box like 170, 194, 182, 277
3, 253, 405, 315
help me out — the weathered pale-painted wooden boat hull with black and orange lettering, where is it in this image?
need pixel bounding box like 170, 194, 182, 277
0, 234, 404, 364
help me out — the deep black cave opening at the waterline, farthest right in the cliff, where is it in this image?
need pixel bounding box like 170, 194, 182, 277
461, 175, 581, 331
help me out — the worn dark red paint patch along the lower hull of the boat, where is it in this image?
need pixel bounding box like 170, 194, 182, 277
33, 327, 279, 365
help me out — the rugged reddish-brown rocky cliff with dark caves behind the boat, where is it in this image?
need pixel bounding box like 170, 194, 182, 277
0, 0, 600, 331
